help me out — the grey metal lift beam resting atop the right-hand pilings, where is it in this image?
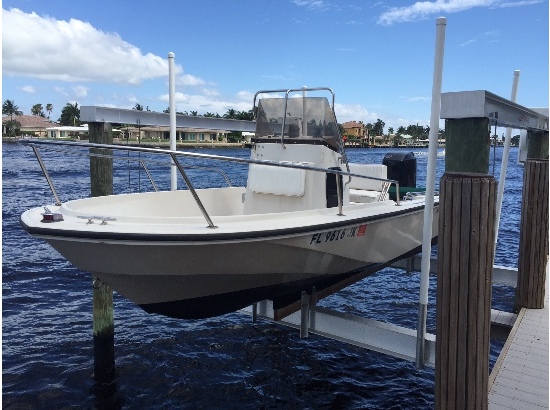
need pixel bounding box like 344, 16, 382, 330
441, 90, 548, 131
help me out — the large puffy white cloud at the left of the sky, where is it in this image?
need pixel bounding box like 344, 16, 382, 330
2, 9, 202, 85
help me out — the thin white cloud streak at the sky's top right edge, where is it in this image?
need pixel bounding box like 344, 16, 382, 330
378, 0, 498, 26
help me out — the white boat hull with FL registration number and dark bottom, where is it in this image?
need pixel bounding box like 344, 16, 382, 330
21, 188, 437, 318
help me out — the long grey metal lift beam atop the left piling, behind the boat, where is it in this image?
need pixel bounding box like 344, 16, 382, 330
80, 105, 256, 132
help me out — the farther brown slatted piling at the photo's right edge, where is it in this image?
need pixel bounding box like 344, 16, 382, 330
515, 132, 548, 311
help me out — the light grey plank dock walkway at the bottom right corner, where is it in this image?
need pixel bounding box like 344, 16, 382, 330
489, 267, 549, 410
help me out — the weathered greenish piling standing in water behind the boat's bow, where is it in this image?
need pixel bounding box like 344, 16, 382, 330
88, 122, 115, 382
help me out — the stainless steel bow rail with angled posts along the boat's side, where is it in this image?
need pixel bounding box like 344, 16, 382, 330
20, 140, 401, 228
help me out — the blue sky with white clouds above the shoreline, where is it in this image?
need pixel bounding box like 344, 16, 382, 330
2, 0, 549, 132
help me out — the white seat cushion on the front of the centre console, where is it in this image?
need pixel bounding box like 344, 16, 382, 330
248, 162, 309, 196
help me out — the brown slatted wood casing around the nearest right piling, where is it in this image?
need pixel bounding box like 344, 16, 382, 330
435, 172, 497, 409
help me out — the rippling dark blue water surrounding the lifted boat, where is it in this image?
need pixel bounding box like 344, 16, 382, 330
2, 144, 523, 409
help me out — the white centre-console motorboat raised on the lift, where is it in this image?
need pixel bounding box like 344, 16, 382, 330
21, 87, 438, 319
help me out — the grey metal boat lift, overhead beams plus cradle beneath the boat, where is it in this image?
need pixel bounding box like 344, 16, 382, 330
77, 52, 548, 367
